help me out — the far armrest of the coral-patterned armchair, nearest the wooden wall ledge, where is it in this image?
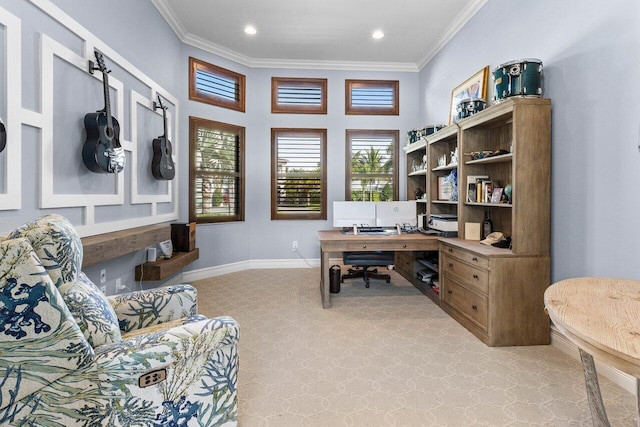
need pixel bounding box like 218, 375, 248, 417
108, 284, 197, 332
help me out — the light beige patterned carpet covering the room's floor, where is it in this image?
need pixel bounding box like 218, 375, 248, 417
193, 268, 635, 427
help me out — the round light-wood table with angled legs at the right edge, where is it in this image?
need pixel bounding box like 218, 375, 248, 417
544, 277, 640, 426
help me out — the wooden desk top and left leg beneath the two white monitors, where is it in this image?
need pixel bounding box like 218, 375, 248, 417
318, 230, 438, 308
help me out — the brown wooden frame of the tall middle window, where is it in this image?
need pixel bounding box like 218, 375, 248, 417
271, 128, 327, 220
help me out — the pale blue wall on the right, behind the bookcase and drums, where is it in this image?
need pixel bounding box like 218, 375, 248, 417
420, 0, 640, 281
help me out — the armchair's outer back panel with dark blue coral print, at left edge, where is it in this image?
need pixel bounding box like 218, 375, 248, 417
0, 238, 94, 409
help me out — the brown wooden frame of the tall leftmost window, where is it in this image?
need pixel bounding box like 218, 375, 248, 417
189, 116, 246, 224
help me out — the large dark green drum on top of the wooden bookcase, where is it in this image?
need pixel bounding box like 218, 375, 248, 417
493, 58, 542, 102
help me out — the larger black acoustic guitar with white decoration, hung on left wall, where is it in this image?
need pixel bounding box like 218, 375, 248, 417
82, 50, 126, 173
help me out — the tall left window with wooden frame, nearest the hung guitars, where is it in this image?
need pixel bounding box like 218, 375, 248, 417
189, 117, 245, 223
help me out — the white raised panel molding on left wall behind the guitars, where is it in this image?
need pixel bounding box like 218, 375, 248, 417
5, 0, 179, 236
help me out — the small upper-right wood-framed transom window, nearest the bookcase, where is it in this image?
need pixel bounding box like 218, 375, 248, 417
345, 80, 400, 116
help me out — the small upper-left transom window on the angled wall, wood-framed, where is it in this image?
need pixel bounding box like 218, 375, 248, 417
189, 58, 246, 112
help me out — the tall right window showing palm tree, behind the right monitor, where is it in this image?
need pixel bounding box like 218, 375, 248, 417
345, 130, 400, 202
